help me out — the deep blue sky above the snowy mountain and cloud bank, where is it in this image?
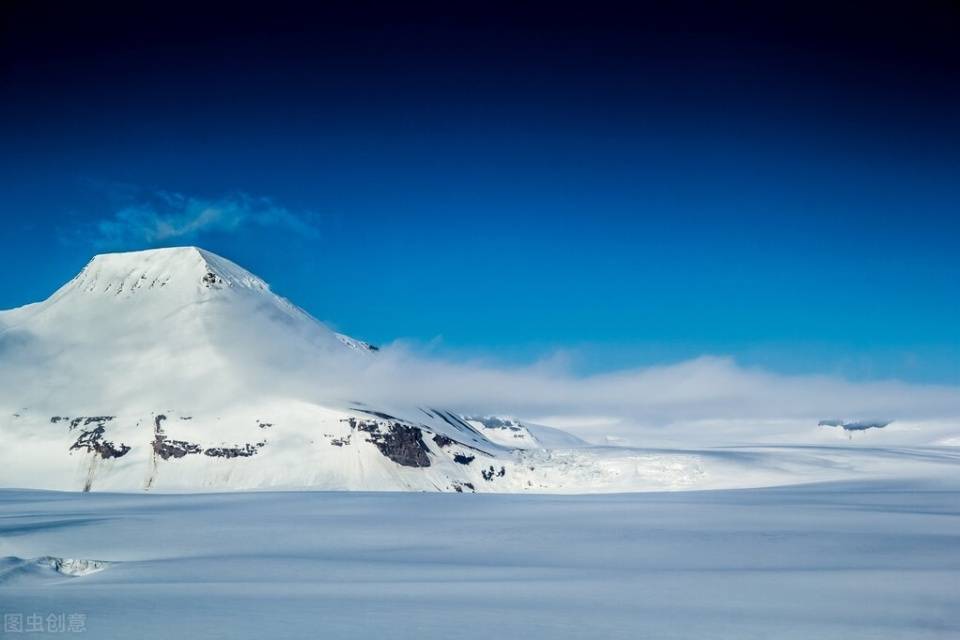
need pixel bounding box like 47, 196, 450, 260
0, 3, 960, 383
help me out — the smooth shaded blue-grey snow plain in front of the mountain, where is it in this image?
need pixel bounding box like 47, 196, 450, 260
0, 480, 960, 640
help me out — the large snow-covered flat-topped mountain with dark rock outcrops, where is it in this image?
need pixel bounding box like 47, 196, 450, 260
0, 247, 952, 493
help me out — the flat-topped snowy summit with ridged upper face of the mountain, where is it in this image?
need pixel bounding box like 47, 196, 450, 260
68, 246, 269, 296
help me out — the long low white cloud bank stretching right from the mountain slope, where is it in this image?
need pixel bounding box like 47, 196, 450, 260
312, 345, 960, 447
